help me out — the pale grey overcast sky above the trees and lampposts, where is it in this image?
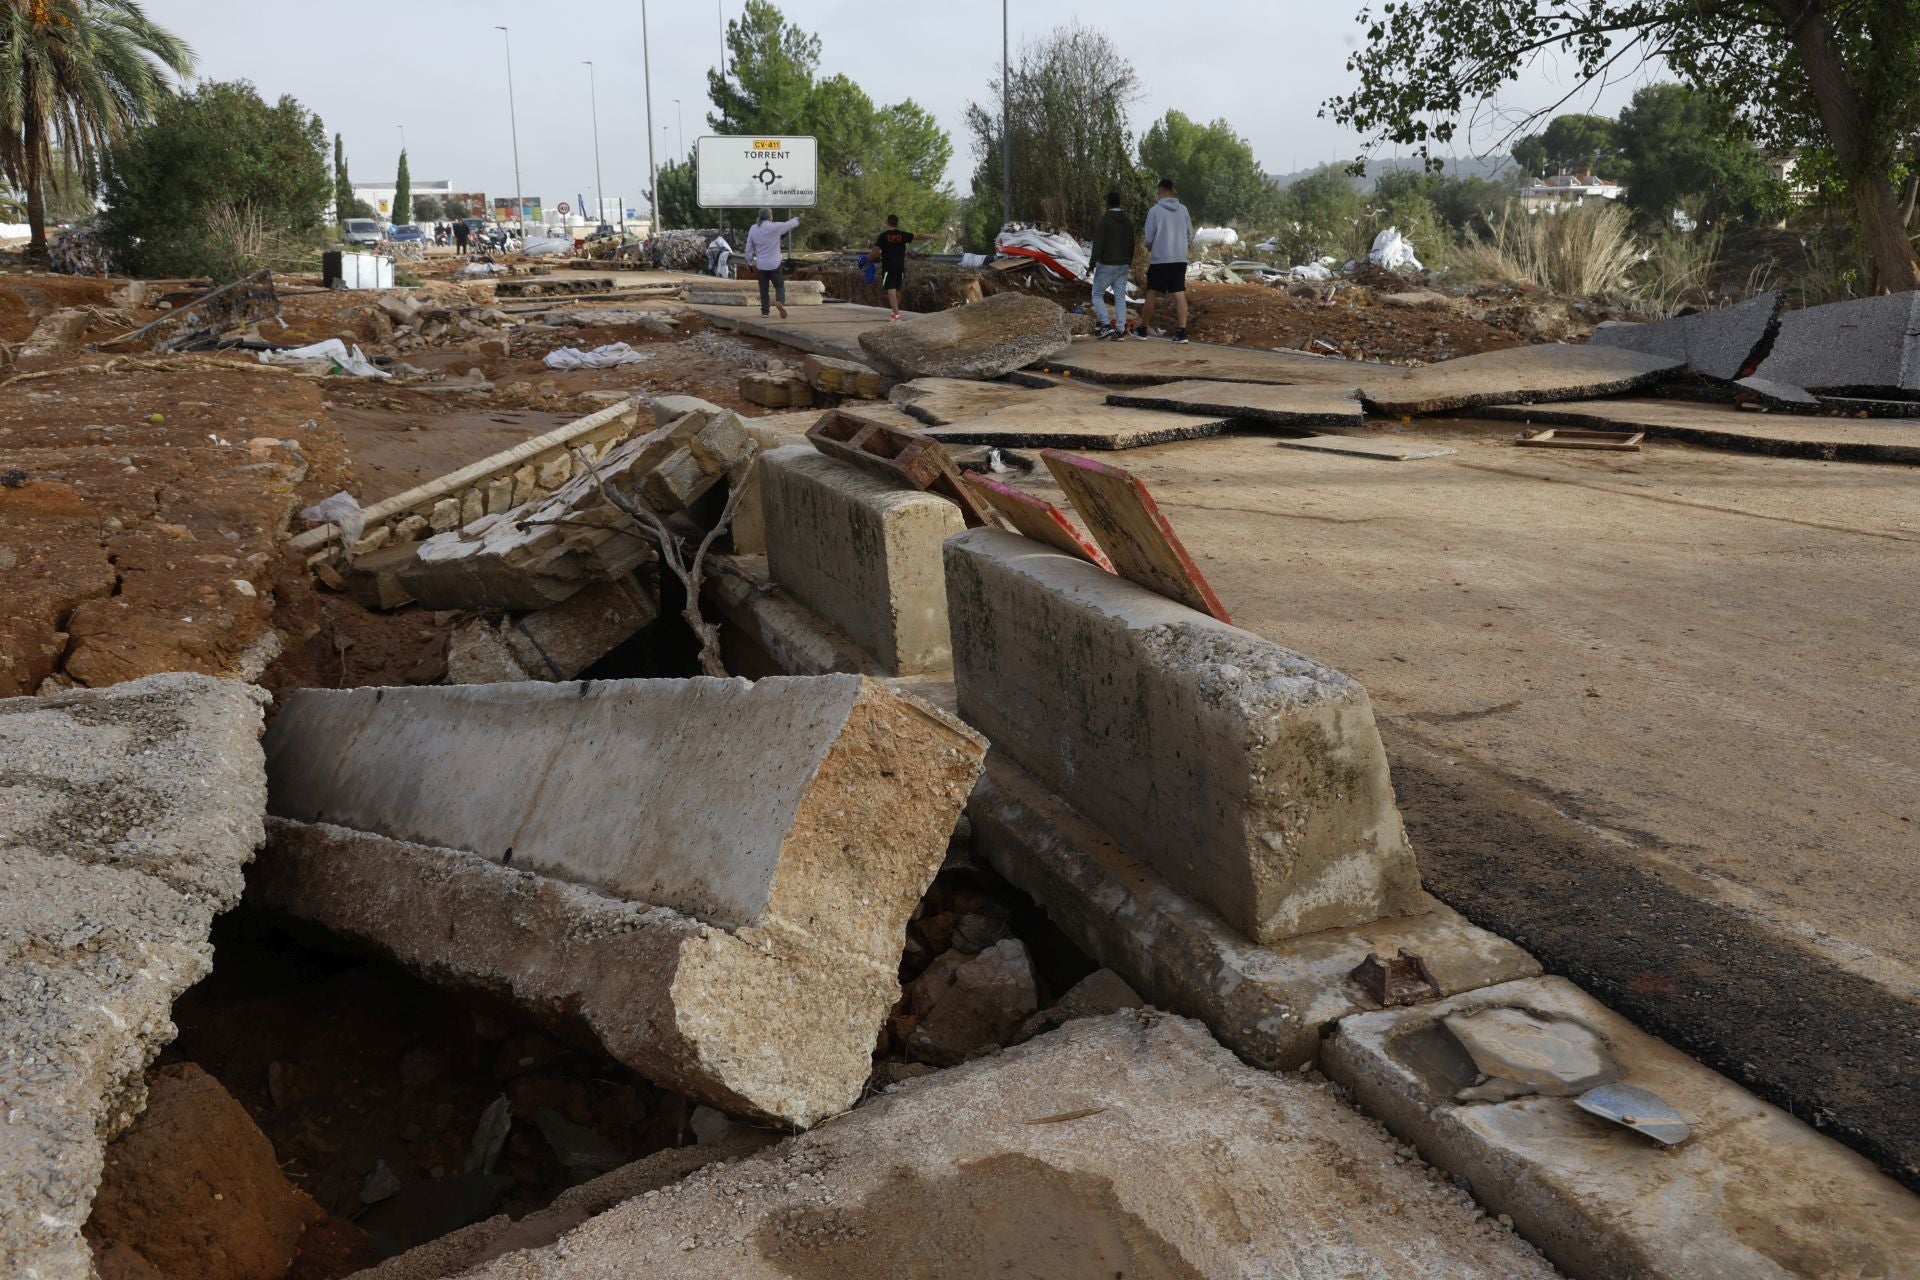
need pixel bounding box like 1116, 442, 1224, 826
146, 0, 1666, 209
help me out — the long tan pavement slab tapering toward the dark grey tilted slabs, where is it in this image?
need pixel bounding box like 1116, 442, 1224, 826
1359, 344, 1686, 418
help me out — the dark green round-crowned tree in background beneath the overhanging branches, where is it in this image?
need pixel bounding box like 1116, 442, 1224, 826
1619, 84, 1786, 226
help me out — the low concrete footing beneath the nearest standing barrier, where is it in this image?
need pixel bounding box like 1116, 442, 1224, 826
968, 752, 1540, 1071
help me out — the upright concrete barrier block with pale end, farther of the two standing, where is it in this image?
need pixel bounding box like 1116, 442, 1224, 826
760, 445, 966, 674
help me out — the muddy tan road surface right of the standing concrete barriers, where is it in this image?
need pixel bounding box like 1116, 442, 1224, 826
1029, 424, 1920, 1178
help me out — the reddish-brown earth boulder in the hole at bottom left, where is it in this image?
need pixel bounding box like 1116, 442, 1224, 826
84, 1063, 321, 1280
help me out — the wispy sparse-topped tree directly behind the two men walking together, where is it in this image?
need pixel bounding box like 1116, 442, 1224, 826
966, 23, 1152, 246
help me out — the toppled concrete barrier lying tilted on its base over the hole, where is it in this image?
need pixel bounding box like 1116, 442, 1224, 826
267, 676, 985, 963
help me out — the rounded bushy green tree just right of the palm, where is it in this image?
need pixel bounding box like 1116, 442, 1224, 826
102, 81, 332, 274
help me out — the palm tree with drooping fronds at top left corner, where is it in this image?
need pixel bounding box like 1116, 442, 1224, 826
0, 0, 194, 255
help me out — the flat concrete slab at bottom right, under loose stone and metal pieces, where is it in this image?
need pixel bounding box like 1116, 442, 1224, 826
1325, 977, 1920, 1280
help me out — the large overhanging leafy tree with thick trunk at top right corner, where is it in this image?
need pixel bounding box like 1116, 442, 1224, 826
1323, 0, 1920, 290
